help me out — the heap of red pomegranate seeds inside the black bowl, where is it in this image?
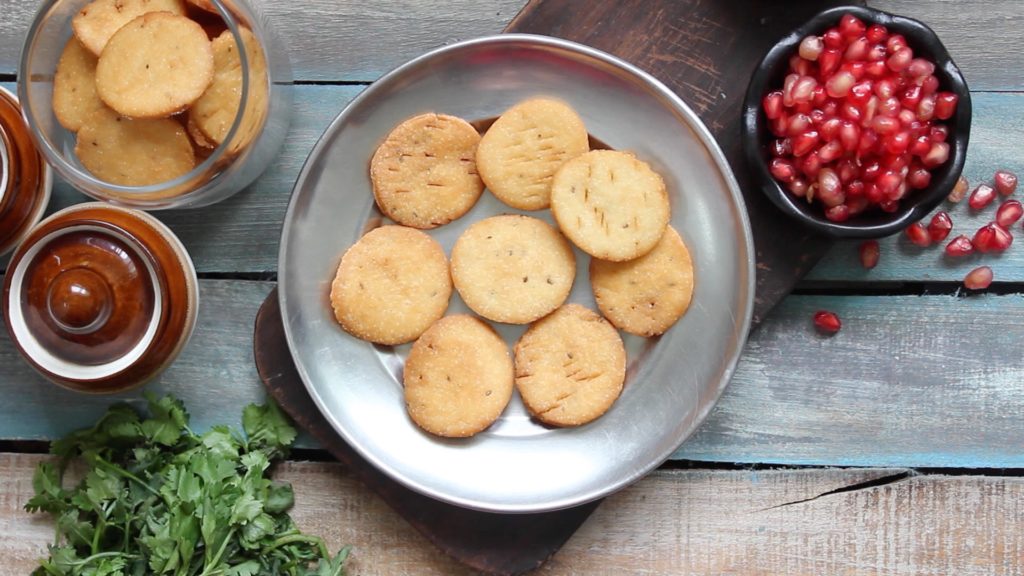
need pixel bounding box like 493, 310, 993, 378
762, 14, 954, 221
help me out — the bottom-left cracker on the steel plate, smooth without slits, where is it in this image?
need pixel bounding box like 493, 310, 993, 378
402, 315, 513, 438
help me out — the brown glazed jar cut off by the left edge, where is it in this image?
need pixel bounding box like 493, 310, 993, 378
0, 88, 53, 255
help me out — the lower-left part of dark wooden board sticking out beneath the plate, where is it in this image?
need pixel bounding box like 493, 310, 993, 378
253, 288, 598, 574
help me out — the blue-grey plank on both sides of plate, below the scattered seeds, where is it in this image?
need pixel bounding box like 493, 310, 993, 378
0, 280, 1024, 467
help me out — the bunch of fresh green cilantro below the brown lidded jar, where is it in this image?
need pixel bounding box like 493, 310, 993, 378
26, 396, 348, 576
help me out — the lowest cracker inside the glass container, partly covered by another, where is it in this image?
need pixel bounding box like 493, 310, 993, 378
75, 109, 196, 186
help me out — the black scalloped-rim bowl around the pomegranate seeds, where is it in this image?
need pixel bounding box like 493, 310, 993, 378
742, 6, 971, 238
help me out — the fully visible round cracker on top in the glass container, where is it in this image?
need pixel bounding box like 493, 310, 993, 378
96, 12, 213, 118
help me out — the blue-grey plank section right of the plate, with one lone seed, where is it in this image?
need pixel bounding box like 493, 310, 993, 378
674, 294, 1024, 467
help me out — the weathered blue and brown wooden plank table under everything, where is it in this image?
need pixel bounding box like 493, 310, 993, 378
0, 0, 1024, 575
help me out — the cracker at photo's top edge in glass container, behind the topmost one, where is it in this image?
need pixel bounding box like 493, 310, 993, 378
71, 0, 185, 56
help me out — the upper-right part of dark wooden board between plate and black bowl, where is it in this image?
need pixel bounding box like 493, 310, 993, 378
505, 0, 856, 324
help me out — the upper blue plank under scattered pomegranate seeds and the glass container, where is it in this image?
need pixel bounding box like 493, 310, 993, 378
0, 84, 1024, 283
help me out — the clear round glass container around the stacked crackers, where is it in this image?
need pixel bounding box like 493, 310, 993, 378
17, 0, 292, 210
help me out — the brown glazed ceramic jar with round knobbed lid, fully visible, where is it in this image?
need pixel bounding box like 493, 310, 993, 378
2, 202, 199, 394
